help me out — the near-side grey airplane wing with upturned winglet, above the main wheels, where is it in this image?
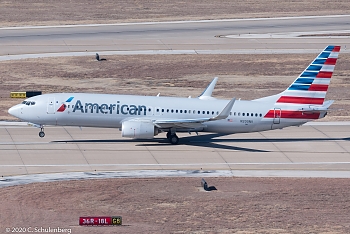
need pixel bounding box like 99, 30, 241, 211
153, 98, 236, 128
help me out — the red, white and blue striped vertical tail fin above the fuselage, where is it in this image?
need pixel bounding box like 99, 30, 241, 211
277, 45, 340, 105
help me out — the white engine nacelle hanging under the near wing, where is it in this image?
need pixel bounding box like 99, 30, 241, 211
122, 120, 158, 139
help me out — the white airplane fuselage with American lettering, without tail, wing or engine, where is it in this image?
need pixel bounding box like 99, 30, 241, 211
9, 93, 309, 134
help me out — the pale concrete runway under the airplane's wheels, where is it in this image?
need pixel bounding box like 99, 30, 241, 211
0, 122, 350, 177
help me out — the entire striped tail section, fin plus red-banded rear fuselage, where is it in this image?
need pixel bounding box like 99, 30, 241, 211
255, 45, 340, 122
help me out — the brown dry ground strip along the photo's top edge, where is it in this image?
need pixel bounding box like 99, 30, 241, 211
0, 0, 350, 27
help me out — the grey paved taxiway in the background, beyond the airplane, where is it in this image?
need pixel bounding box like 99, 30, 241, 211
0, 15, 350, 60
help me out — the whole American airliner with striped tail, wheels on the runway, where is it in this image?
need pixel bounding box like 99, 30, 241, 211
8, 45, 340, 145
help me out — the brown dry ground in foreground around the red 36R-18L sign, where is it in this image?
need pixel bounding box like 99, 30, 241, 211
0, 177, 350, 234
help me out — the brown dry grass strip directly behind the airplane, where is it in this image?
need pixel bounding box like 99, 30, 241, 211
0, 53, 350, 121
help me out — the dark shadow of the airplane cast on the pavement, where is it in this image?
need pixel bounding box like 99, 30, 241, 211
52, 133, 350, 152
